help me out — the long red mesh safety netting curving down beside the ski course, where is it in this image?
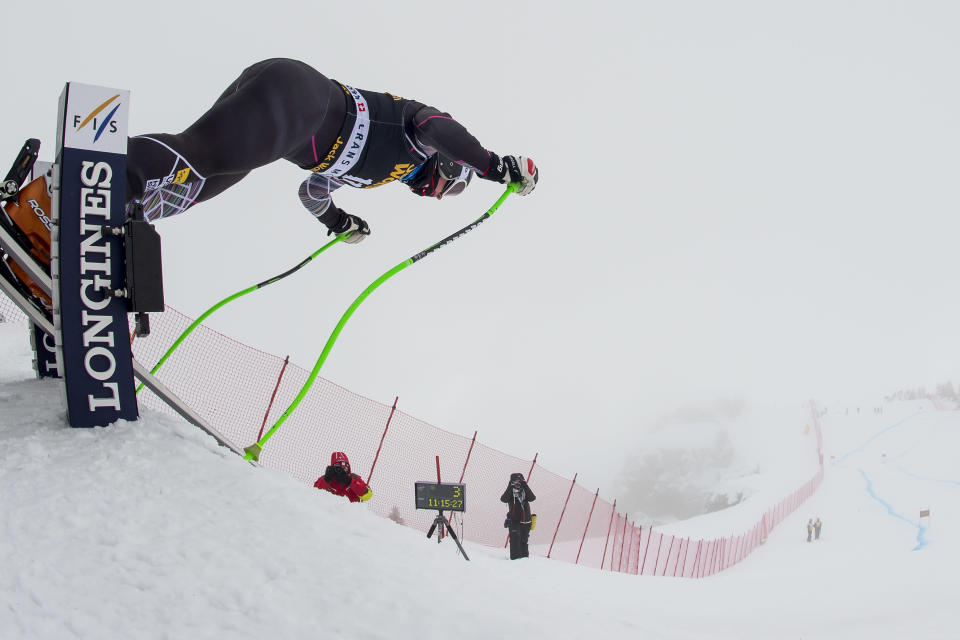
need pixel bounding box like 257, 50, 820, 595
0, 295, 823, 577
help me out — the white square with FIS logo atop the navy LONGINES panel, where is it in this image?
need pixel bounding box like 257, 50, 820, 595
61, 82, 130, 154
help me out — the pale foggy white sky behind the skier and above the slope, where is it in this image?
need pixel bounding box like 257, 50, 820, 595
0, 0, 960, 484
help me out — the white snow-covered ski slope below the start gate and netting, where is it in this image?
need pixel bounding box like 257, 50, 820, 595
0, 323, 960, 640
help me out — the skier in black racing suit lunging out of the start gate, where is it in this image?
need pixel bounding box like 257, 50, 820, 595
127, 58, 539, 243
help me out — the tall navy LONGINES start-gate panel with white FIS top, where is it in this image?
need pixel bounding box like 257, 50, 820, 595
52, 82, 138, 427
